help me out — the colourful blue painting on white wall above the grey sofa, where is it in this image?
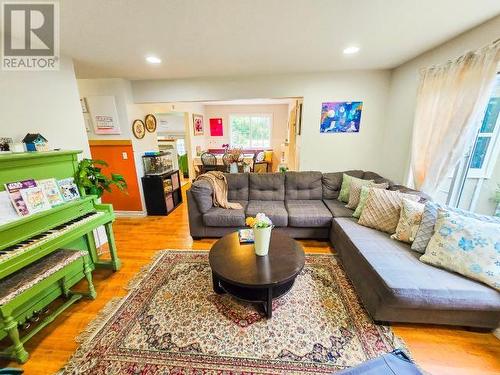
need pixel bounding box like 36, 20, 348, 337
319, 102, 363, 133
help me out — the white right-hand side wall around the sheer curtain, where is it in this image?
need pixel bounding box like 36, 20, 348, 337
381, 16, 500, 182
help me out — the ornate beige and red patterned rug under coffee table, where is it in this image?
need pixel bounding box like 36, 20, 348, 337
61, 251, 402, 375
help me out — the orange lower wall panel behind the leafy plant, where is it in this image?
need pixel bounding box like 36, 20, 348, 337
90, 141, 142, 211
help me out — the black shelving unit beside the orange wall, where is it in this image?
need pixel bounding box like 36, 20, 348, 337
142, 170, 182, 216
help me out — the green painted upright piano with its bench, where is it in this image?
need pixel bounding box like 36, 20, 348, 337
0, 151, 120, 363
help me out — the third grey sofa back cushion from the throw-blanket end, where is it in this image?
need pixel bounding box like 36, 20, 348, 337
285, 172, 323, 199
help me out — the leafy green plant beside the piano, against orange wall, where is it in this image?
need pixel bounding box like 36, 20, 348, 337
74, 159, 127, 198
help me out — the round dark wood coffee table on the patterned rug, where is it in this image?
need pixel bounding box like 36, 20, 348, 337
209, 229, 305, 318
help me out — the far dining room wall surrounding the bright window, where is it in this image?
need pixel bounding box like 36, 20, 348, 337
205, 104, 288, 170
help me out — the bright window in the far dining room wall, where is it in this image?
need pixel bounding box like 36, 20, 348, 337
229, 114, 272, 148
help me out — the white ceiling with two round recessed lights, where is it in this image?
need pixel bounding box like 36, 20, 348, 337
60, 0, 500, 79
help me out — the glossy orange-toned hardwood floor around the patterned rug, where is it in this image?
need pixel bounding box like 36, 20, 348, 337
0, 187, 500, 375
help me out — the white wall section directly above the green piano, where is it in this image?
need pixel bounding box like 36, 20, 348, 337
0, 57, 90, 157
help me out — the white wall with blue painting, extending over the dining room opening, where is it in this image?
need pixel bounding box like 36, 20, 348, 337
132, 71, 390, 172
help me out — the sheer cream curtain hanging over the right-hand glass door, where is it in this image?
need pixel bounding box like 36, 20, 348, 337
411, 41, 500, 197
